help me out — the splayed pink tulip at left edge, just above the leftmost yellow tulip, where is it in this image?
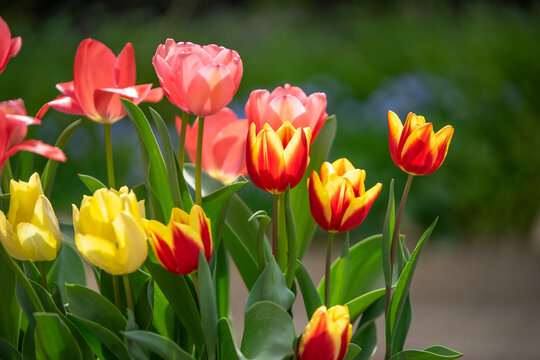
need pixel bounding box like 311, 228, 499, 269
0, 99, 66, 171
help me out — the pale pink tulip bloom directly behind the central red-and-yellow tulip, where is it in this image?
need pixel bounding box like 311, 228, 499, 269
245, 84, 328, 139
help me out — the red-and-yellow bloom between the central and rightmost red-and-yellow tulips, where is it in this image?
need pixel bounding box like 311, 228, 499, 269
308, 158, 382, 232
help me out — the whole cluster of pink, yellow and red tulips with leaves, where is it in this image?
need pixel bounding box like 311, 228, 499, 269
0, 18, 460, 360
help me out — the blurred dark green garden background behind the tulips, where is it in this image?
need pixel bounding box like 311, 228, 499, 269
0, 0, 540, 241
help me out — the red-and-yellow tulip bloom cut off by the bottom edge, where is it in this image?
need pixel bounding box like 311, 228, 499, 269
298, 305, 352, 360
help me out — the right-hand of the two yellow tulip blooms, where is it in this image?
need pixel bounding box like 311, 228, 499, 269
73, 186, 148, 275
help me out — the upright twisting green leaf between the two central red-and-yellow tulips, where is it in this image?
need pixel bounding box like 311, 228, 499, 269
291, 115, 337, 260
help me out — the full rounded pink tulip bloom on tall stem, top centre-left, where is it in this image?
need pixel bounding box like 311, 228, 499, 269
152, 39, 243, 116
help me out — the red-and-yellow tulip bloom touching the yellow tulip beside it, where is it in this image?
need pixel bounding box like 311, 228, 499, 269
145, 204, 212, 275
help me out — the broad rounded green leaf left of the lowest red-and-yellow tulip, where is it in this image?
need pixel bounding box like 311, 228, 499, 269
241, 301, 296, 360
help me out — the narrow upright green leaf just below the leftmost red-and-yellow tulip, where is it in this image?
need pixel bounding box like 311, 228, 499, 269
198, 251, 218, 359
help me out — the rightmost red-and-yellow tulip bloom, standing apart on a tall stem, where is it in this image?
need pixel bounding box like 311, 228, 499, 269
388, 111, 454, 175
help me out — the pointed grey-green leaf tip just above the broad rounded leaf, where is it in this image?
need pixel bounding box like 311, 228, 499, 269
246, 257, 295, 310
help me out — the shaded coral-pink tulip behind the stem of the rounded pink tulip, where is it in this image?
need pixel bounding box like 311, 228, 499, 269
176, 108, 248, 184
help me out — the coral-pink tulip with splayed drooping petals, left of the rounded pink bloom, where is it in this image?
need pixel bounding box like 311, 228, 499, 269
38, 39, 163, 124
